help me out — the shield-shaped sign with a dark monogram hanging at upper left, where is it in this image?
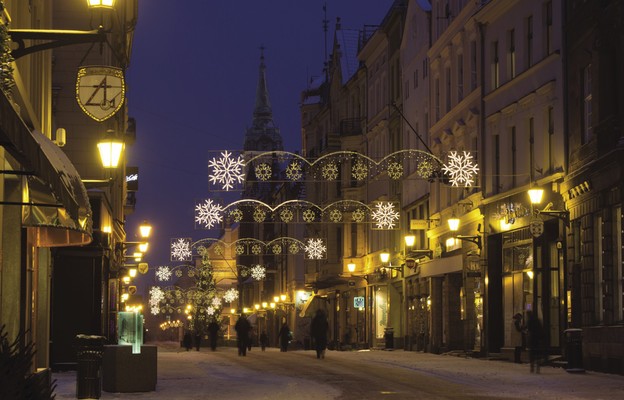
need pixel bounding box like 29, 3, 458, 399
76, 66, 126, 122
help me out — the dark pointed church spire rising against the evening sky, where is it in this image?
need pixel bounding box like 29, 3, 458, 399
244, 46, 284, 151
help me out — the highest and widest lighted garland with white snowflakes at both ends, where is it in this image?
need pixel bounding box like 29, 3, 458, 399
208, 149, 478, 191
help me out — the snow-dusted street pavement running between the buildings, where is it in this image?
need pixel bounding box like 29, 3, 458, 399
54, 348, 624, 400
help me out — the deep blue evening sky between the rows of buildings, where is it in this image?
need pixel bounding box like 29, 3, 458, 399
126, 0, 392, 269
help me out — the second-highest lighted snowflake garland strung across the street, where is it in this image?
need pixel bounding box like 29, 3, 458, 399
195, 199, 400, 230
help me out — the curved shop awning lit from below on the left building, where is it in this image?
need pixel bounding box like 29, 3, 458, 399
0, 94, 93, 247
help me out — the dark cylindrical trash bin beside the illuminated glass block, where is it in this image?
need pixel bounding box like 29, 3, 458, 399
76, 335, 106, 399
